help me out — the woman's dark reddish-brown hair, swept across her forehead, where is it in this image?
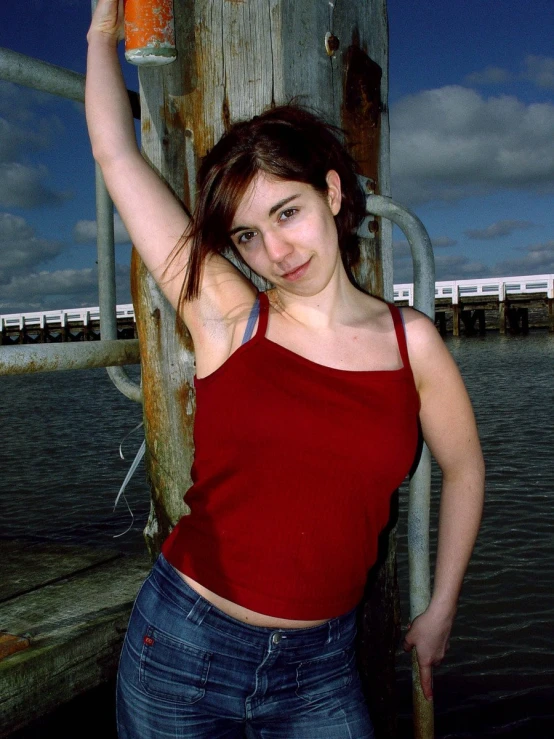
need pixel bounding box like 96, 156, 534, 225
176, 105, 365, 302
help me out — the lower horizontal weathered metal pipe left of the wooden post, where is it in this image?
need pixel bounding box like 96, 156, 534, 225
0, 339, 140, 375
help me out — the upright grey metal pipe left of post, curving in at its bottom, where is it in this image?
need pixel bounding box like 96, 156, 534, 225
96, 164, 142, 403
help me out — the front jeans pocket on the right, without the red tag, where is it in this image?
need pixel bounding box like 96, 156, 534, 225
296, 649, 356, 702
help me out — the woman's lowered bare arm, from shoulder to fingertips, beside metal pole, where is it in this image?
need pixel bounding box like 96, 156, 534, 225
396, 311, 485, 699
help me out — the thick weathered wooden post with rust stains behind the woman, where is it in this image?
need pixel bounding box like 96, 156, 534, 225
133, 0, 398, 737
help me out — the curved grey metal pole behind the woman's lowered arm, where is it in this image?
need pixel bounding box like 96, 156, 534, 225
366, 195, 435, 739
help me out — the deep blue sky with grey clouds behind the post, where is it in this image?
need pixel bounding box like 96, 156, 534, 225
0, 0, 554, 313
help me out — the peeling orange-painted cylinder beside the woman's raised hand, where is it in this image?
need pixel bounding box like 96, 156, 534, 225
125, 0, 177, 66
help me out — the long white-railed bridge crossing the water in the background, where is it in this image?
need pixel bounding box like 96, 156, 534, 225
0, 274, 554, 344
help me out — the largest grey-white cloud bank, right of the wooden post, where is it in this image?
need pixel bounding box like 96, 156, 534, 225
391, 85, 554, 204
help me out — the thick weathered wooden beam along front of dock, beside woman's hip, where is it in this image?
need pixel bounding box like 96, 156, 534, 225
0, 551, 150, 737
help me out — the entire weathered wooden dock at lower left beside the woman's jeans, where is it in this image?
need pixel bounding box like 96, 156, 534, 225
0, 541, 151, 737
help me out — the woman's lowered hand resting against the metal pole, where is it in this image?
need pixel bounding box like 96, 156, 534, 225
402, 606, 453, 700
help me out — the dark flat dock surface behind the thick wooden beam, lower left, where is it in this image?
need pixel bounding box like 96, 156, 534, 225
0, 540, 121, 603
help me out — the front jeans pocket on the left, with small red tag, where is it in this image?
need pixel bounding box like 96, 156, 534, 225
139, 626, 212, 704
